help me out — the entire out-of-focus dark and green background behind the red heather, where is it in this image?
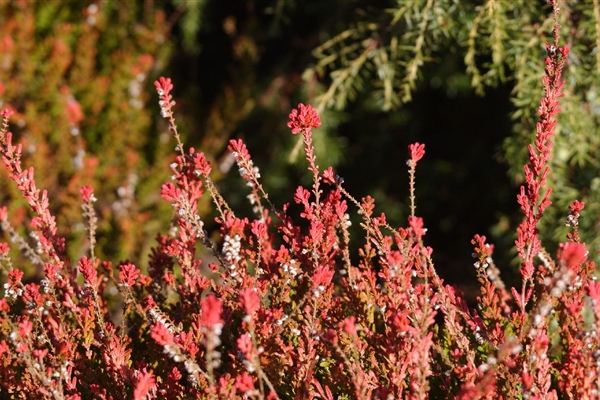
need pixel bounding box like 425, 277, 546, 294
0, 0, 600, 294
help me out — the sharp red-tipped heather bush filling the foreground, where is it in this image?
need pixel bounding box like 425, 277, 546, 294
0, 1, 600, 399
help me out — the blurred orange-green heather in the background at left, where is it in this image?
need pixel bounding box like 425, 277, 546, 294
0, 1, 173, 268
